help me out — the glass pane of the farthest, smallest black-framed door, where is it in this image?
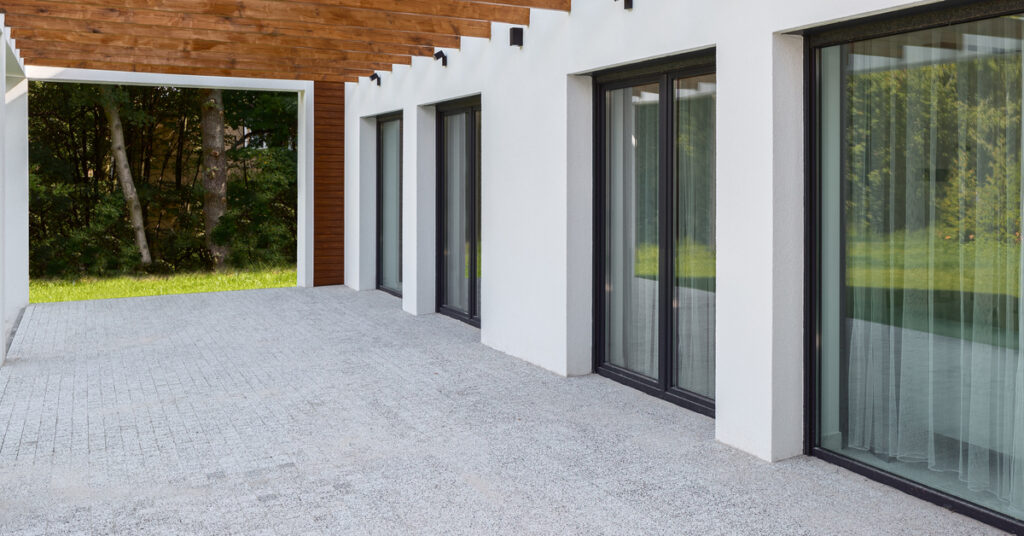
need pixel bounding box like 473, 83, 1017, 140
380, 120, 401, 292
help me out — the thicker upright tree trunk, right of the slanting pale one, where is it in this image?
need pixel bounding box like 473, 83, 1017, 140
201, 89, 227, 270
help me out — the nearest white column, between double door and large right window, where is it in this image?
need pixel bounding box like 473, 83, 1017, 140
716, 29, 804, 461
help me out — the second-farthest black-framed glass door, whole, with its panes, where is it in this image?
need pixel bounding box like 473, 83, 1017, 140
437, 100, 480, 325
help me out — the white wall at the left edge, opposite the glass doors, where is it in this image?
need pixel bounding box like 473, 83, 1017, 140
0, 15, 29, 364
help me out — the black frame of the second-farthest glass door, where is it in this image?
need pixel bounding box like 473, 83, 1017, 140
435, 96, 482, 327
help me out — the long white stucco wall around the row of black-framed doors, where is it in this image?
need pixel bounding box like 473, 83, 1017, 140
345, 0, 927, 460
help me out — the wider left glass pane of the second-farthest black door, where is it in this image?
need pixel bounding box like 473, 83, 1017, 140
443, 114, 472, 314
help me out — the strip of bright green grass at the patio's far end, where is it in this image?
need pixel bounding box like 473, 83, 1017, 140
29, 267, 296, 303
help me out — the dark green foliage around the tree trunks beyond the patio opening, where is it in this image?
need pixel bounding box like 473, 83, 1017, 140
29, 82, 298, 278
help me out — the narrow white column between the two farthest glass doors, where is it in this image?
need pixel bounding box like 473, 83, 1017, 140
401, 107, 437, 315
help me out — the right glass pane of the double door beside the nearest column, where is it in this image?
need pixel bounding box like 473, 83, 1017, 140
673, 75, 715, 398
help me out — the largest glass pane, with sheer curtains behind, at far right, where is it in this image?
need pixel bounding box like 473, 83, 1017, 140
818, 17, 1024, 519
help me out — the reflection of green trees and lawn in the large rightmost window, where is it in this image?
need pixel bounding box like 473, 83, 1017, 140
844, 53, 1022, 295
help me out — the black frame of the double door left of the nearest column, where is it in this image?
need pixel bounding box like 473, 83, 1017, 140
593, 48, 715, 417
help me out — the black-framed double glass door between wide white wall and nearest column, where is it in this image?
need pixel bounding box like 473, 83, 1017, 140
595, 54, 715, 414
